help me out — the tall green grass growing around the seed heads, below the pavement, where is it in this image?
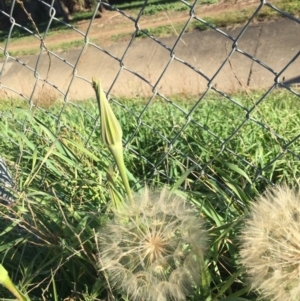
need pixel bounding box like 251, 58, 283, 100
0, 90, 300, 301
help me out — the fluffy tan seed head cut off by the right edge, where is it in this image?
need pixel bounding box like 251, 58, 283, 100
240, 185, 300, 301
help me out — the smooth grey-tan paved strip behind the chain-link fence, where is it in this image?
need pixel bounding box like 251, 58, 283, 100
1, 19, 300, 100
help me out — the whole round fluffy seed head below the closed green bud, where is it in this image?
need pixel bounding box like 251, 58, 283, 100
98, 188, 207, 301
